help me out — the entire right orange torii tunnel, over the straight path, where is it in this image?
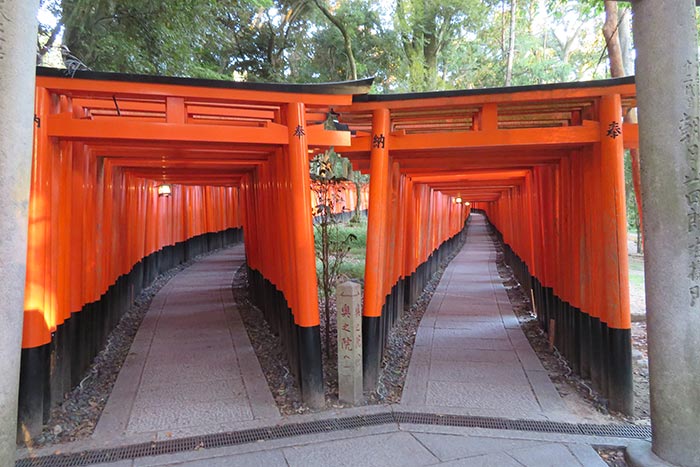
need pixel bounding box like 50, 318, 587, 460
336, 78, 638, 413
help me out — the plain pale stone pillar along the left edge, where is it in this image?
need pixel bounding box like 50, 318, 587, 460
0, 0, 39, 465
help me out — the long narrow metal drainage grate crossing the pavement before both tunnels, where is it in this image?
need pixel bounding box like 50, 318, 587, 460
15, 412, 651, 467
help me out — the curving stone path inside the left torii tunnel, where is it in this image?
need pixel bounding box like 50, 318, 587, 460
94, 245, 280, 438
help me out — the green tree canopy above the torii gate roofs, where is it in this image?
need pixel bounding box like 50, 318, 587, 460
37, 0, 608, 92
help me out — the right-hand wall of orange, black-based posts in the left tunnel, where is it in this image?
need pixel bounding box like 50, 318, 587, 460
241, 103, 325, 407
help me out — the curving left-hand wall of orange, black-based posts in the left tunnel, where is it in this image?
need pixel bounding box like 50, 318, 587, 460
19, 88, 242, 439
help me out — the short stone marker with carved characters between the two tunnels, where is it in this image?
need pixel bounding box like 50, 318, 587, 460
335, 282, 362, 405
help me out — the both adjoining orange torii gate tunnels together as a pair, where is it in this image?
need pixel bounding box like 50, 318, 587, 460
20, 68, 638, 434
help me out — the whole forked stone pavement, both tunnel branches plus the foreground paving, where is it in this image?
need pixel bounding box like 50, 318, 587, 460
18, 229, 616, 467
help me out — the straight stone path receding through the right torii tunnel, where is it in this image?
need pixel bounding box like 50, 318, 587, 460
401, 214, 572, 420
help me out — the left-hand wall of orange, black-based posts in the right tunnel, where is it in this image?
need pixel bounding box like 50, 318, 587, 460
362, 109, 469, 391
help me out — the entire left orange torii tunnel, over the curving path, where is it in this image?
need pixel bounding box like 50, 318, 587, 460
20, 68, 371, 434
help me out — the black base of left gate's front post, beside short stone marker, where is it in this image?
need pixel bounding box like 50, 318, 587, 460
297, 326, 326, 409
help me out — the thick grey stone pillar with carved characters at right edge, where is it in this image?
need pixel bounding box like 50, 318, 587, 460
632, 0, 700, 467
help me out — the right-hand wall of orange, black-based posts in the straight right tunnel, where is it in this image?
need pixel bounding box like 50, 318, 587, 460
475, 95, 633, 414
